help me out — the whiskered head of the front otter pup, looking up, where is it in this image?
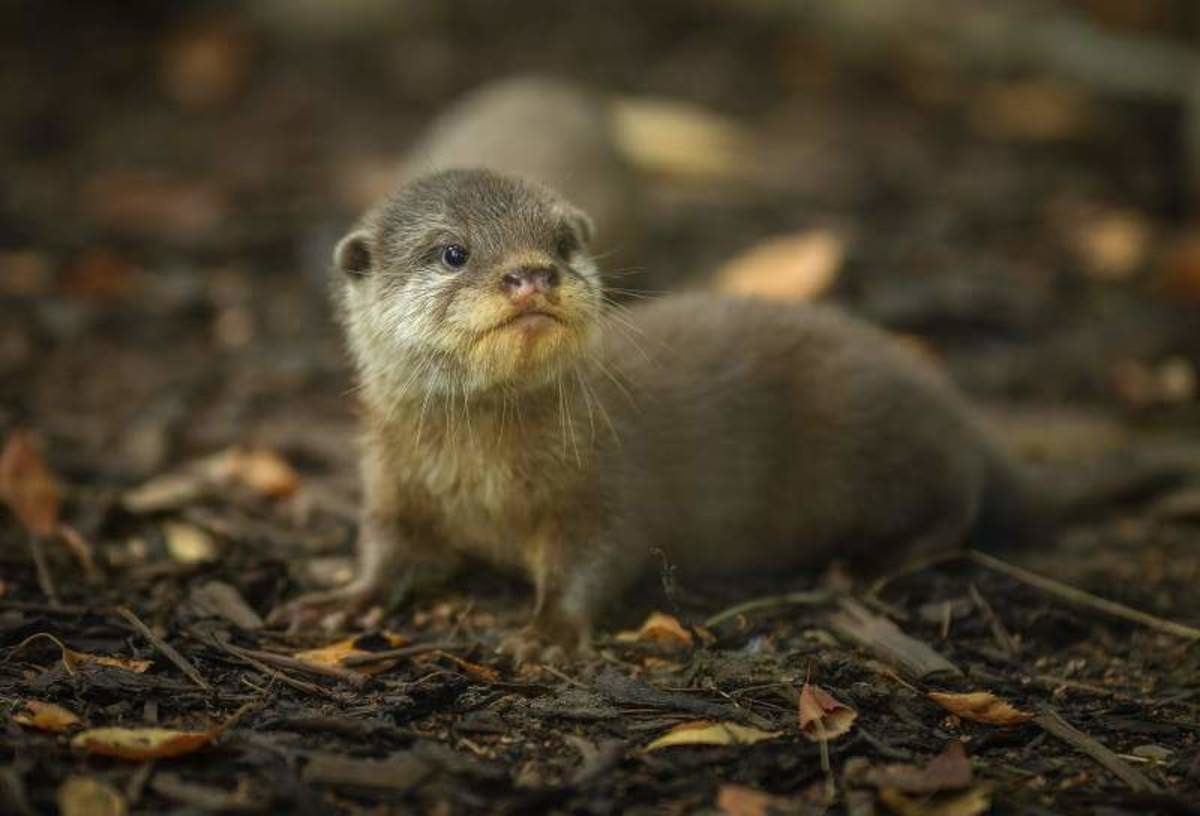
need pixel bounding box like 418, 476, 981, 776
335, 170, 604, 396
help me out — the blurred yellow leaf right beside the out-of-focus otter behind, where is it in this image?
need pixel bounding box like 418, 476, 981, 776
613, 98, 754, 179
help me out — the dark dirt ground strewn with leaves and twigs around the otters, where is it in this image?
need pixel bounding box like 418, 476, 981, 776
0, 0, 1200, 816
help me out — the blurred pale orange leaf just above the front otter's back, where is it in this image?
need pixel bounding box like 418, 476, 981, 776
715, 229, 846, 302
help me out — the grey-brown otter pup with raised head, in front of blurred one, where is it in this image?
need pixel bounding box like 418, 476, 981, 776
276, 170, 1027, 659
